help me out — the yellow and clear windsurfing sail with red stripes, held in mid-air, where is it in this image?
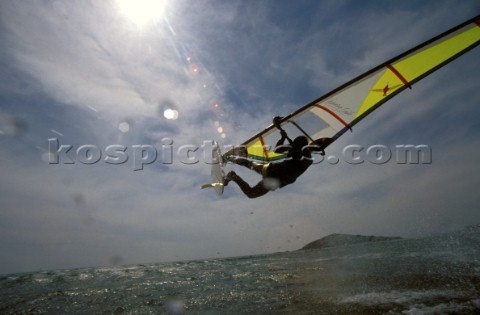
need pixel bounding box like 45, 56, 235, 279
242, 15, 480, 163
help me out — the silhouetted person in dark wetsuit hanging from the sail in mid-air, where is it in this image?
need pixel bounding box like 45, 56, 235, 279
224, 117, 323, 198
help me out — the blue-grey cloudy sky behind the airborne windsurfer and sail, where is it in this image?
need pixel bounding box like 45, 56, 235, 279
0, 0, 480, 274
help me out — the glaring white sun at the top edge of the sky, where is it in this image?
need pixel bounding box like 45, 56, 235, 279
117, 0, 166, 27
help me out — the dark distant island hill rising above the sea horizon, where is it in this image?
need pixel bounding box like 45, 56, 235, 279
300, 233, 401, 250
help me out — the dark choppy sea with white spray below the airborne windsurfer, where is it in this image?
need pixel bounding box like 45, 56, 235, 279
0, 225, 480, 314
